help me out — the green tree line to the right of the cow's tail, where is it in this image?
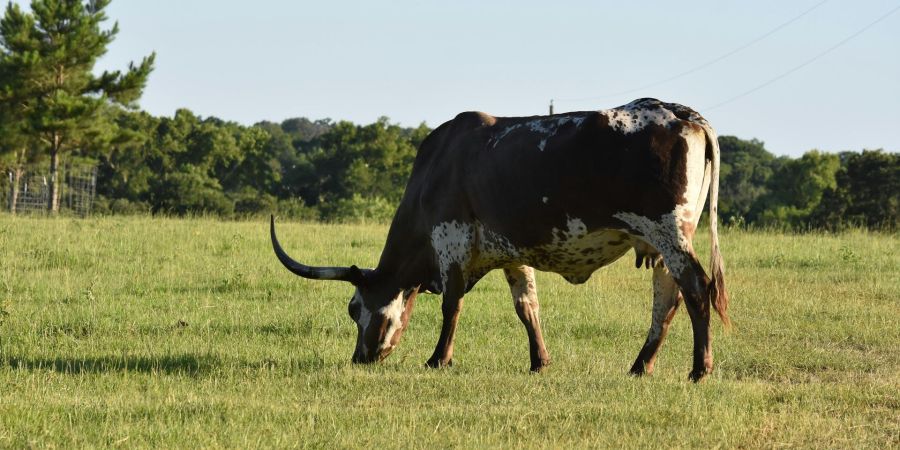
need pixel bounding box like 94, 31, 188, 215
719, 136, 900, 230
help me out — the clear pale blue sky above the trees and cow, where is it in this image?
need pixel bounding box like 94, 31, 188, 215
77, 0, 900, 156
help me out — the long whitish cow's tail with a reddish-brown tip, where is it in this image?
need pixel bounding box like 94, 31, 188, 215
703, 124, 731, 328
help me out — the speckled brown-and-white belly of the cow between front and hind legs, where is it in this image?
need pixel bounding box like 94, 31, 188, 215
471, 221, 634, 284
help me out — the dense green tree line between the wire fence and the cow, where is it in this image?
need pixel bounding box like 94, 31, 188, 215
96, 109, 430, 221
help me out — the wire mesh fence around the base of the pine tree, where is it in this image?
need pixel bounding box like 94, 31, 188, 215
0, 165, 97, 217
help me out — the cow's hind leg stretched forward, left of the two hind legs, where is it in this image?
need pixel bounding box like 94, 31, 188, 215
631, 263, 681, 375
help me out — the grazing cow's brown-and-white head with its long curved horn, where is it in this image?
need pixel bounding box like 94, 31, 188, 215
270, 216, 419, 363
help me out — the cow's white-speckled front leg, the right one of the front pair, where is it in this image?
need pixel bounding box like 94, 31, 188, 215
503, 266, 550, 372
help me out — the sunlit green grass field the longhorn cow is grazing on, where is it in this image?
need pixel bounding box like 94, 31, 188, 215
0, 215, 900, 448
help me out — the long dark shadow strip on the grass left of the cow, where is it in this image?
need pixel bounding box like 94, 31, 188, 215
0, 353, 220, 376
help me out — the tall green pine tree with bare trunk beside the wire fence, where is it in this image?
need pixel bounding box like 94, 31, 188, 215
0, 0, 155, 212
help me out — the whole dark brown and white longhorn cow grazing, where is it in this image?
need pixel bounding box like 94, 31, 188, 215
270, 98, 729, 381
